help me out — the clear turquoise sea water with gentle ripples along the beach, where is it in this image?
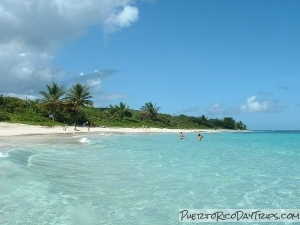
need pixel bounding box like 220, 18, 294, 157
0, 131, 300, 225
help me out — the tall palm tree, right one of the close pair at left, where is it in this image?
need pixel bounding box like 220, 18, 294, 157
66, 83, 94, 130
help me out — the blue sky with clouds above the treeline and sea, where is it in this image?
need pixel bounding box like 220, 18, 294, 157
0, 0, 300, 129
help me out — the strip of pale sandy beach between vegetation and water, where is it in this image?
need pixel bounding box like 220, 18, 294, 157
0, 122, 244, 137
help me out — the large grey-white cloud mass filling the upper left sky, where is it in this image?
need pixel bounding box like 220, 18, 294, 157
0, 0, 138, 95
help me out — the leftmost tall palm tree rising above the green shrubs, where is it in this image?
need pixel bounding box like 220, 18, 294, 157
39, 82, 65, 120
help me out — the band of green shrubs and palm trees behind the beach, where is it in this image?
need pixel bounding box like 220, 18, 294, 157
0, 83, 246, 130
